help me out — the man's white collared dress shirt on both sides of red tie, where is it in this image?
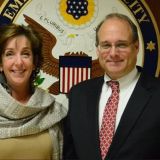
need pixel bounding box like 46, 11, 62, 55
99, 68, 140, 130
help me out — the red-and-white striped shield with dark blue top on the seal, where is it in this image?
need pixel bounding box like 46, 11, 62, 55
59, 56, 92, 93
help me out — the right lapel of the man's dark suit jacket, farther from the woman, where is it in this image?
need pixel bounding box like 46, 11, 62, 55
107, 73, 151, 157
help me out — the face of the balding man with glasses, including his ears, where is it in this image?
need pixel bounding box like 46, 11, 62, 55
97, 18, 139, 79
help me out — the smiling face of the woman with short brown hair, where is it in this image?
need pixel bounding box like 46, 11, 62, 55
1, 35, 35, 88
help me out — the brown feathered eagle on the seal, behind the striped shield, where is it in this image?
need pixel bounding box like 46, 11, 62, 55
23, 14, 104, 95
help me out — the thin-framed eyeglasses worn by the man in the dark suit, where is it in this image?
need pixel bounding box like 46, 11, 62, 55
98, 42, 133, 52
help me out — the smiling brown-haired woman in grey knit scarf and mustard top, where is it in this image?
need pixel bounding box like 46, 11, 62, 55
0, 24, 67, 160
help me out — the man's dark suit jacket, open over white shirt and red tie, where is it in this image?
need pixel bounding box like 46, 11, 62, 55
64, 68, 160, 160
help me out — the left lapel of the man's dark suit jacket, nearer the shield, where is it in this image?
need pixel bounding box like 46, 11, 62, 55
86, 77, 104, 159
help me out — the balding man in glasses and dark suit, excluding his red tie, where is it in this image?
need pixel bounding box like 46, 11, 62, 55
64, 13, 160, 160
